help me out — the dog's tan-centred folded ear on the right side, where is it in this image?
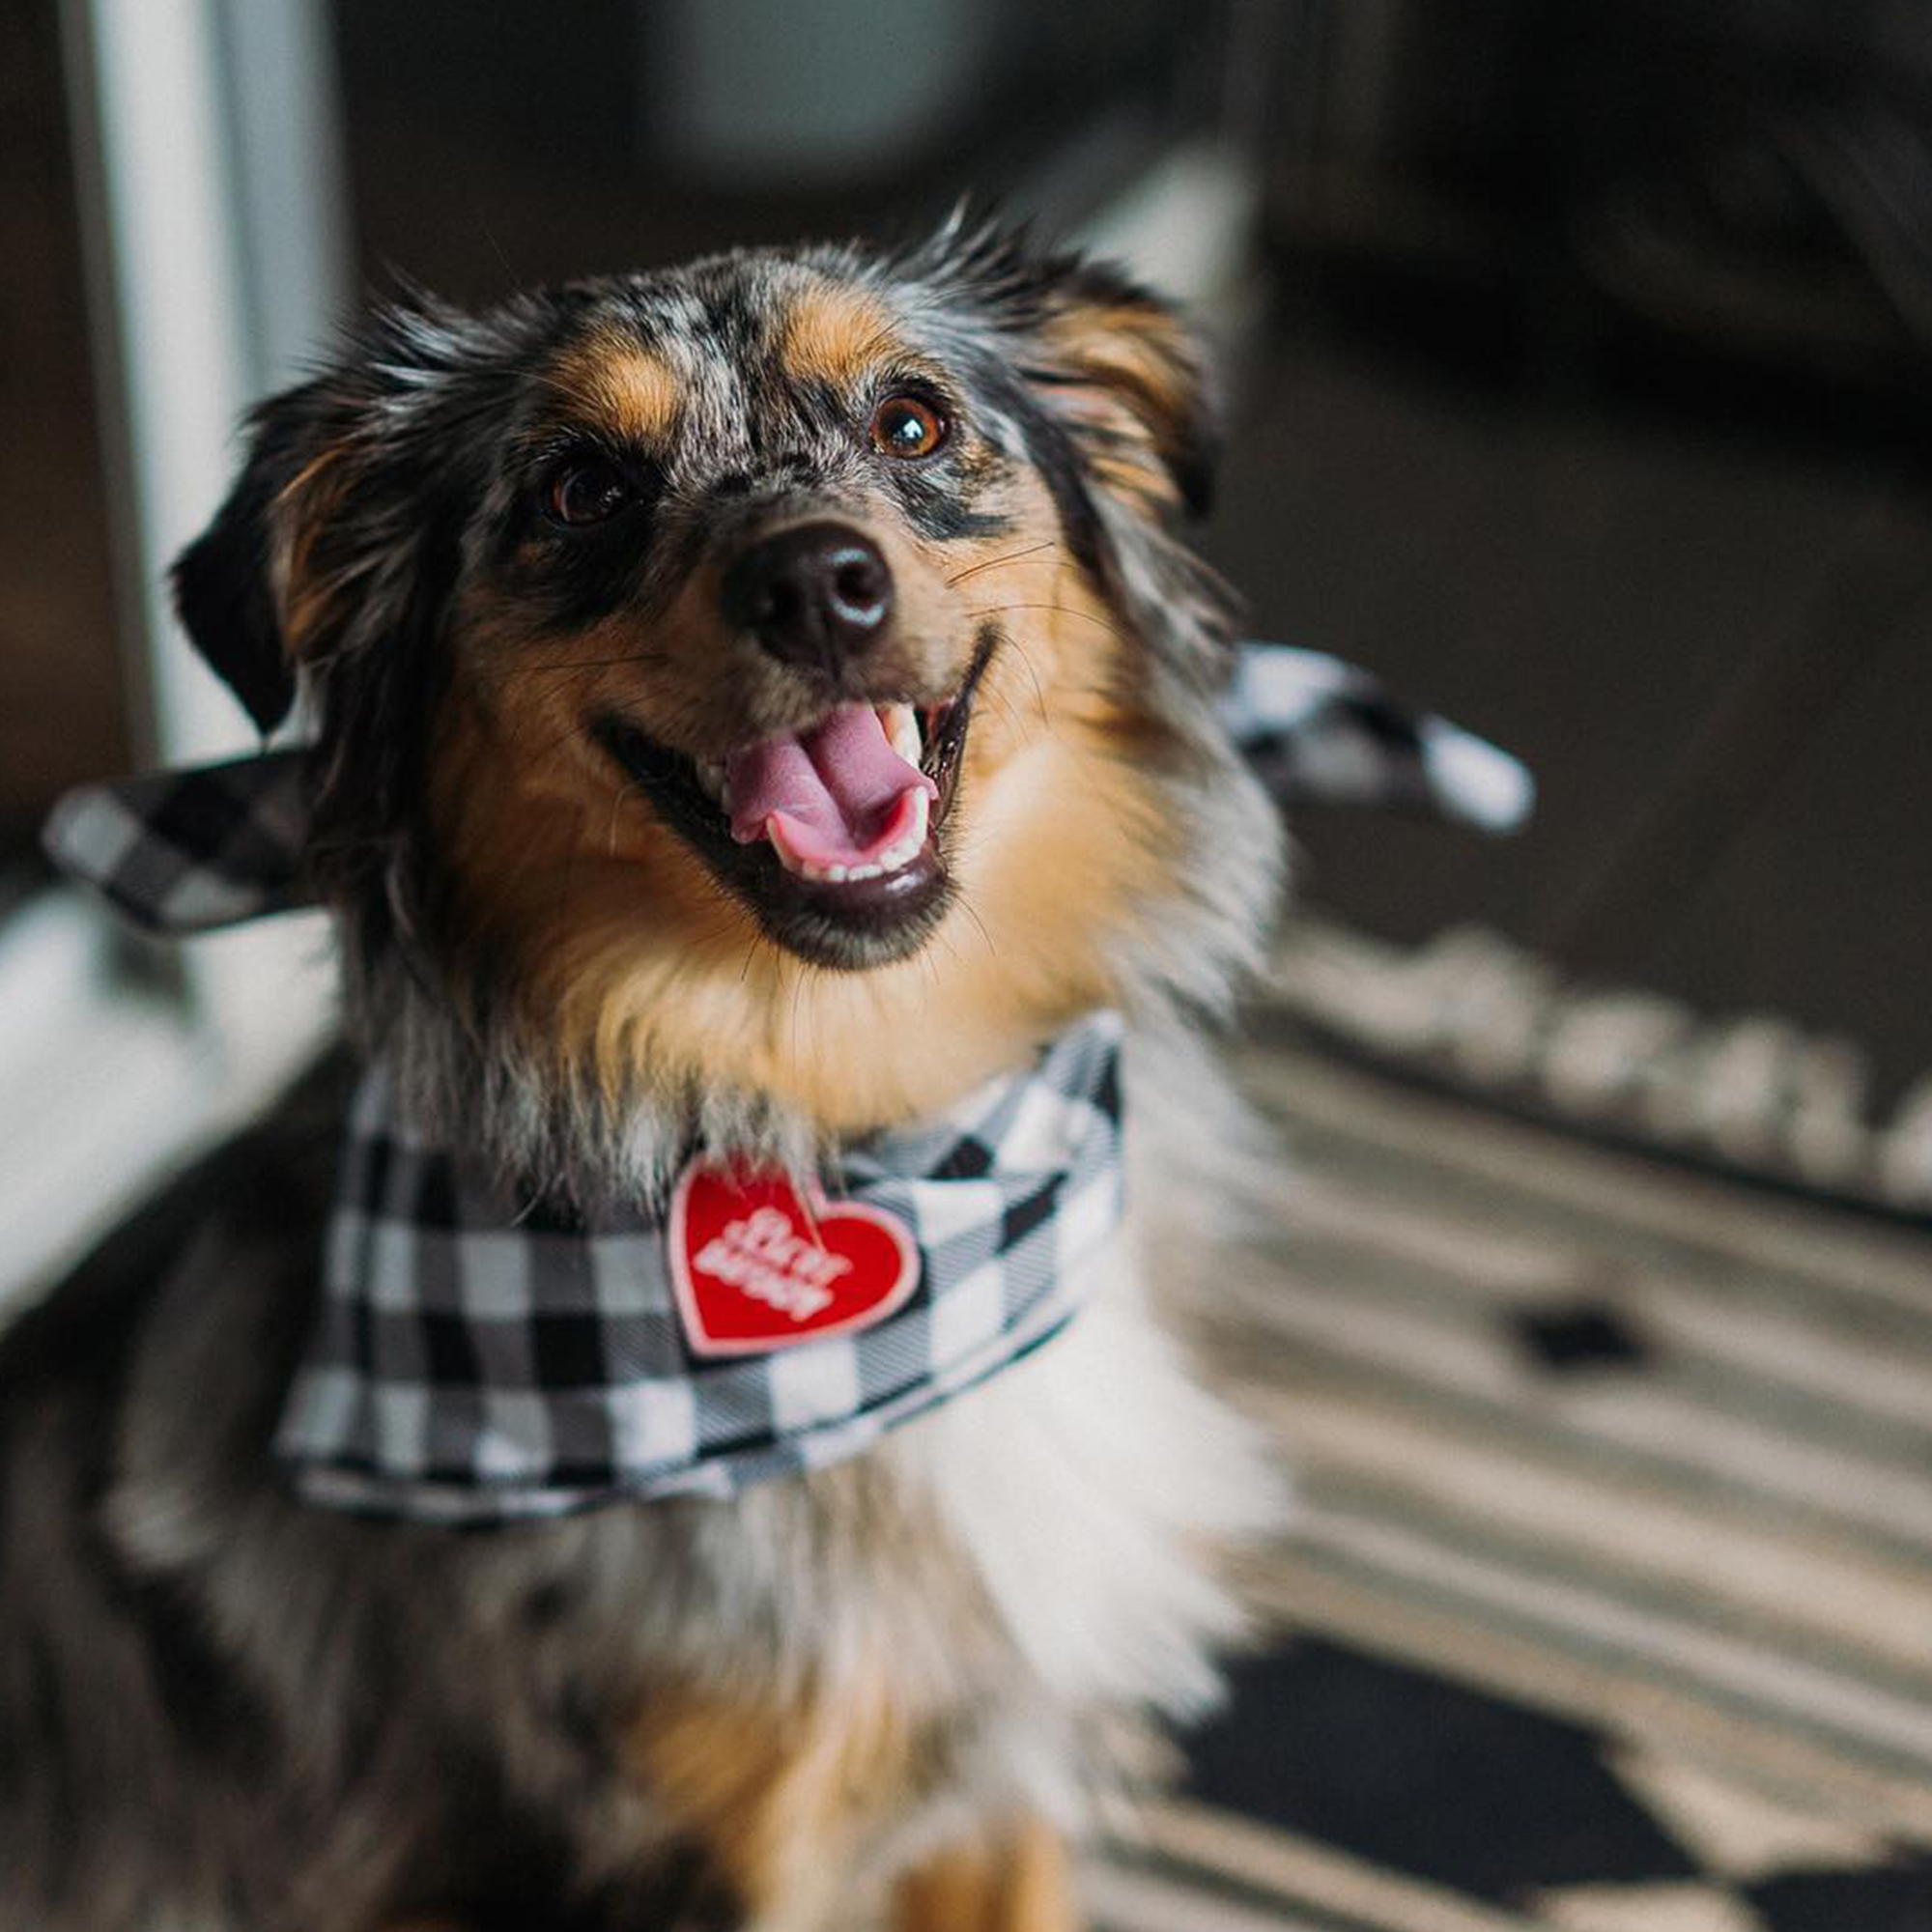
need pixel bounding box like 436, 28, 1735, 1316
1022, 257, 1219, 520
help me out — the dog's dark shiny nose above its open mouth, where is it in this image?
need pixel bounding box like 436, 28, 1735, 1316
723, 524, 893, 672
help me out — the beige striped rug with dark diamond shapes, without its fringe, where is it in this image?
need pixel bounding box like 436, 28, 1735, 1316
1088, 1028, 1932, 1932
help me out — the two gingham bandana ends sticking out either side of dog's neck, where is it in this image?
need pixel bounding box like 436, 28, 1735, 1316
43, 643, 1534, 933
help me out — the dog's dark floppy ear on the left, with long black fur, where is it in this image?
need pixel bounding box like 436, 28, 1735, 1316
174, 294, 500, 970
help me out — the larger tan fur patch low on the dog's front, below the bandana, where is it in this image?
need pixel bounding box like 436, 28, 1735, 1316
636, 1673, 918, 1932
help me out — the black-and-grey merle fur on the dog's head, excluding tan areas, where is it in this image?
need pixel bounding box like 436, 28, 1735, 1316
176, 224, 1231, 1186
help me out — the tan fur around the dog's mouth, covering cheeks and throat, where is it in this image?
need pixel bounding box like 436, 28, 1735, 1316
433, 460, 1182, 1134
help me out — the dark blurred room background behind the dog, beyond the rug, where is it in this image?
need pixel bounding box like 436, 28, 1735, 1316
11, 0, 1932, 1105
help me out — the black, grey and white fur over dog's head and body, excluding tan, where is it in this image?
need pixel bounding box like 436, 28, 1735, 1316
0, 224, 1275, 1932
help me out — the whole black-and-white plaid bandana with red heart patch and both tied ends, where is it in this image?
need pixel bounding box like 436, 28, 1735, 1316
44, 643, 1532, 1524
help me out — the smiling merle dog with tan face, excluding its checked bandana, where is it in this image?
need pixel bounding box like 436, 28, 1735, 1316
0, 220, 1283, 1932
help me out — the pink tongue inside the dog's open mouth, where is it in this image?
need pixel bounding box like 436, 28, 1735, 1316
724, 705, 939, 866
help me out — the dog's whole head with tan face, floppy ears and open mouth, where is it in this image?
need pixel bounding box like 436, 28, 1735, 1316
176, 228, 1275, 1167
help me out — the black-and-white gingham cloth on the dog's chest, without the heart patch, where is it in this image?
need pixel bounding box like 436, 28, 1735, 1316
276, 1012, 1121, 1522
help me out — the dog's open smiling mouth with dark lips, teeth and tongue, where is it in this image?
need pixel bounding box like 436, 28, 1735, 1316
595, 643, 991, 966
